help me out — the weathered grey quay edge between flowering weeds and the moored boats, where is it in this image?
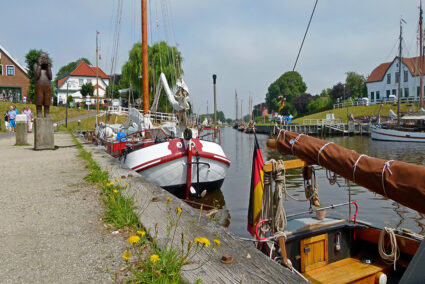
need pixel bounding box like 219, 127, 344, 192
83, 139, 303, 283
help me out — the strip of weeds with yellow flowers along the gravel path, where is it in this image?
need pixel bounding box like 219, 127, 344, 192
73, 133, 215, 284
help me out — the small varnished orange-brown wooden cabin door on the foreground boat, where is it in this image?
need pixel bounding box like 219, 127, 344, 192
300, 234, 328, 272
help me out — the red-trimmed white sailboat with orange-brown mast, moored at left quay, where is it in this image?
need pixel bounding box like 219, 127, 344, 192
95, 0, 230, 199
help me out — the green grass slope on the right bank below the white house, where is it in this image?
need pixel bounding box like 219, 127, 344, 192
292, 104, 418, 124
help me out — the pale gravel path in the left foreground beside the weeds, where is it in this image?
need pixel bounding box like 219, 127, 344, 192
0, 133, 126, 283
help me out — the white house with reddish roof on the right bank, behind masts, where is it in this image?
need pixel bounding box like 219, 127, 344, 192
366, 56, 425, 104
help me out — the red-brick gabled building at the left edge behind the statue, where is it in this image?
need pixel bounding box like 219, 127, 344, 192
0, 45, 30, 102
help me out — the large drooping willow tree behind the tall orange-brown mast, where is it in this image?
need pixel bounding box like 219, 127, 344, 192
121, 41, 183, 112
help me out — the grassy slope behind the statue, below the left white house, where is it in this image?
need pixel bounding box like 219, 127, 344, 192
0, 102, 90, 131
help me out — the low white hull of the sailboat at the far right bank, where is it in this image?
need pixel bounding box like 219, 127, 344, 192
370, 125, 425, 143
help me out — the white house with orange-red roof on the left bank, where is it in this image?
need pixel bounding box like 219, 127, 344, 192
56, 61, 110, 105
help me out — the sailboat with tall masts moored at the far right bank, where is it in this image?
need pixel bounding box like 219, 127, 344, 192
370, 10, 425, 142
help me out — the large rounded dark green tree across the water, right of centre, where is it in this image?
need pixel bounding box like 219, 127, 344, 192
266, 71, 307, 113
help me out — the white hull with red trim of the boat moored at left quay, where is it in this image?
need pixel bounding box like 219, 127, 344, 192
124, 139, 230, 193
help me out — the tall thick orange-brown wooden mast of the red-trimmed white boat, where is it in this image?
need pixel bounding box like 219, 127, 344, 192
142, 0, 149, 114
